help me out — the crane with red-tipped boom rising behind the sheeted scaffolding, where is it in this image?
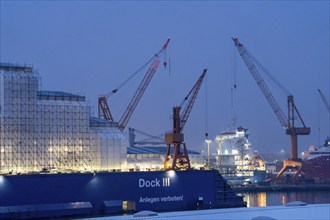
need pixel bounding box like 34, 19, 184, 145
98, 38, 170, 131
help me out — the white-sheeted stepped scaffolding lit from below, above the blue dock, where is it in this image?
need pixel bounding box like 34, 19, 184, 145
0, 63, 127, 174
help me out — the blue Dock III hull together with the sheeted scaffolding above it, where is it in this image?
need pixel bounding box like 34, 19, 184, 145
0, 63, 245, 219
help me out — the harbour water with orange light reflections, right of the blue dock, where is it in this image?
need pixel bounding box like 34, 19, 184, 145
240, 190, 330, 207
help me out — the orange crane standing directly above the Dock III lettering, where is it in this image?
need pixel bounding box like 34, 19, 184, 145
164, 69, 207, 170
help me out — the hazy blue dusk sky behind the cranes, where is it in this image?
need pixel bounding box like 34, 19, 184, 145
0, 0, 330, 157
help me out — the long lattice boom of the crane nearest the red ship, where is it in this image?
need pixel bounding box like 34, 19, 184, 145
232, 38, 288, 129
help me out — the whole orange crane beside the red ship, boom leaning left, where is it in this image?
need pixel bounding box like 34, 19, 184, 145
232, 38, 310, 177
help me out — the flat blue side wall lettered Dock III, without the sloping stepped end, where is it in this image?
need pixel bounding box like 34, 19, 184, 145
0, 170, 218, 213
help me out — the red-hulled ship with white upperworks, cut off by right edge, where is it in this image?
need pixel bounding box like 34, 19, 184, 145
297, 137, 330, 183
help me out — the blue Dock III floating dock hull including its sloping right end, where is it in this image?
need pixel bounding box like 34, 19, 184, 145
0, 170, 244, 218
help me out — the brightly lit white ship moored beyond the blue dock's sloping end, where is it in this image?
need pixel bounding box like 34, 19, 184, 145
215, 127, 266, 185
